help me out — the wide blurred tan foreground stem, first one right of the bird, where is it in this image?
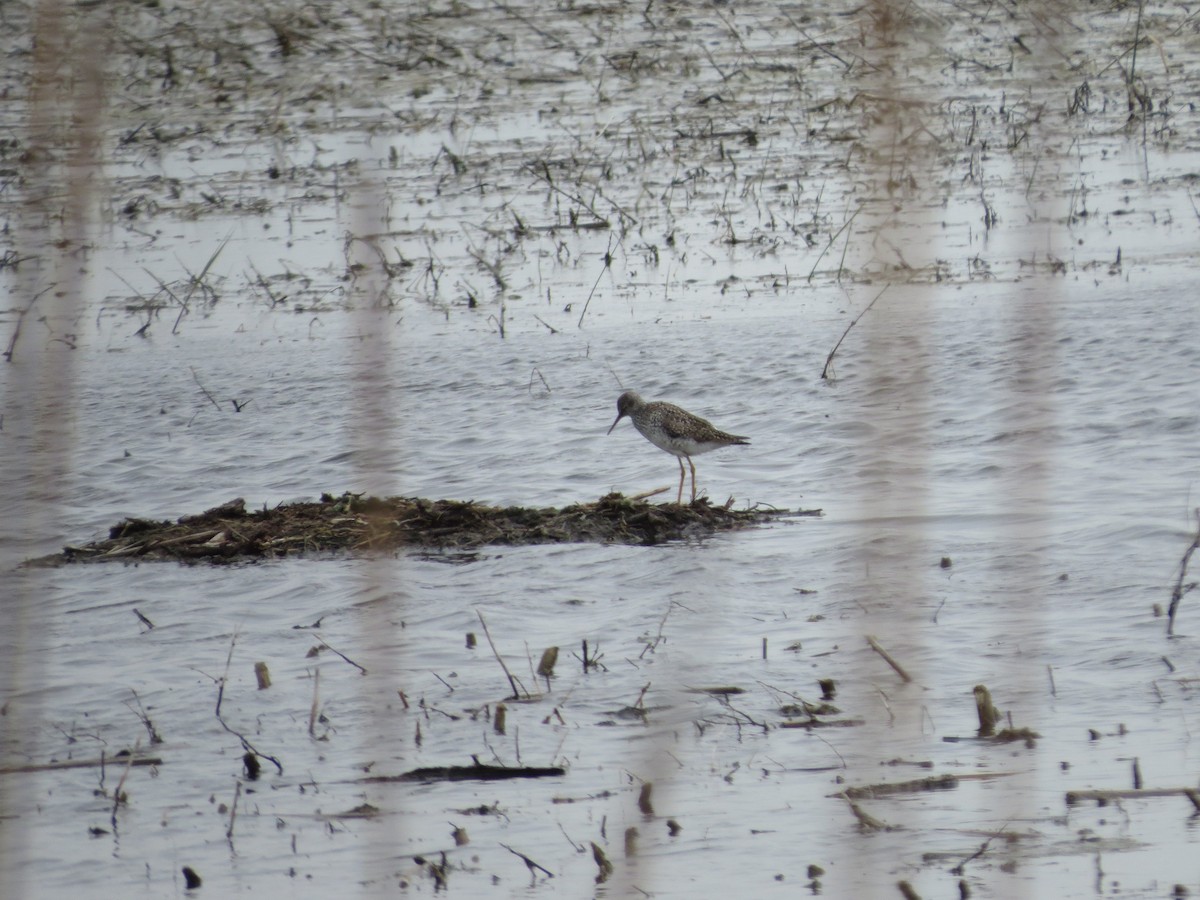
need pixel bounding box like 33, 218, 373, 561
839, 0, 942, 897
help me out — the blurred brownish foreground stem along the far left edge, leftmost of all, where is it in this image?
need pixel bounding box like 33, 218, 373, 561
0, 0, 107, 896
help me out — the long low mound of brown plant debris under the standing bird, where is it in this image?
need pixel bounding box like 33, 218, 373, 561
26, 493, 821, 565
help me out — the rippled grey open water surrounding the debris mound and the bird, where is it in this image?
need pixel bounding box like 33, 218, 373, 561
6, 283, 1196, 896
